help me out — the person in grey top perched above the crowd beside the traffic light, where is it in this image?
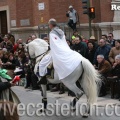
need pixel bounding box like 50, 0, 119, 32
66, 6, 78, 31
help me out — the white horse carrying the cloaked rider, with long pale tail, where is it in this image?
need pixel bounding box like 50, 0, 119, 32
28, 38, 101, 117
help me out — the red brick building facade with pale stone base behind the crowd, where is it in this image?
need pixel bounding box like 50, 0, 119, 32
0, 0, 120, 39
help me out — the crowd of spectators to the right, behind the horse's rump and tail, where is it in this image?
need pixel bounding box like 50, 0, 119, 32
67, 31, 120, 99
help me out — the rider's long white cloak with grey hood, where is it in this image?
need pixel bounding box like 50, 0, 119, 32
49, 27, 82, 80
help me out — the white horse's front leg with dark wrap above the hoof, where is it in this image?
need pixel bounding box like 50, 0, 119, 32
41, 85, 47, 112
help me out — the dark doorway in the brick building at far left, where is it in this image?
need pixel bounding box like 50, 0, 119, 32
0, 10, 8, 35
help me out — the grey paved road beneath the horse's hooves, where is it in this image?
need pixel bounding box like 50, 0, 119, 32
13, 87, 120, 120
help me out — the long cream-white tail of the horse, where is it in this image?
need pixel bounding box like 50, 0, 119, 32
81, 58, 101, 104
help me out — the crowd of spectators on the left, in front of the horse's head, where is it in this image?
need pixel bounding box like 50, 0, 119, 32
0, 34, 39, 90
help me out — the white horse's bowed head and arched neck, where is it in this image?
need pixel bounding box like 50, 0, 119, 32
27, 38, 49, 58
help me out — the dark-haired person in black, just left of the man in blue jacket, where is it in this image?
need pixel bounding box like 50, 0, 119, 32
86, 42, 95, 64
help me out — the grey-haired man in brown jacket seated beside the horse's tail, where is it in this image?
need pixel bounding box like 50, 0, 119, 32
97, 55, 111, 97
